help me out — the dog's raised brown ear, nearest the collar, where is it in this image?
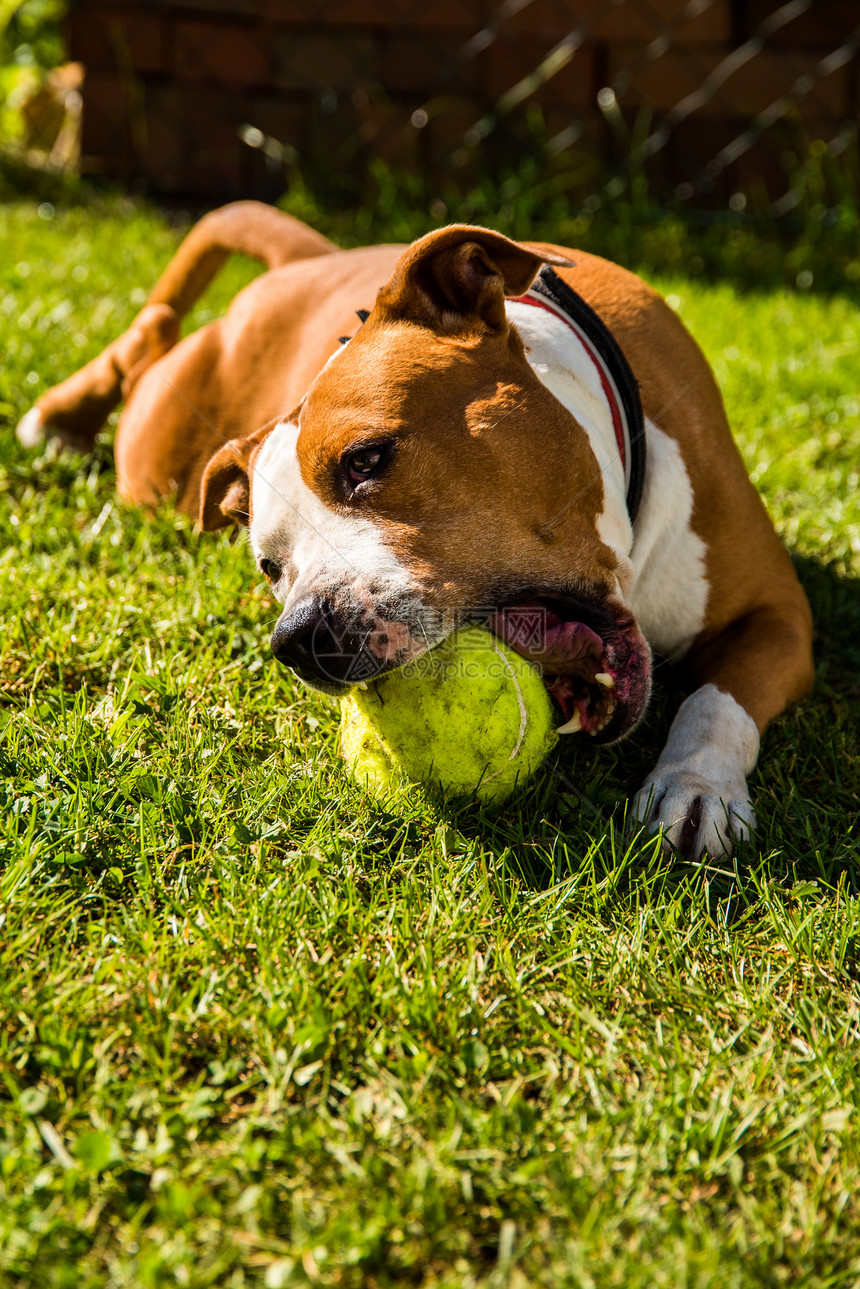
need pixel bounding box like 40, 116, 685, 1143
376, 224, 571, 331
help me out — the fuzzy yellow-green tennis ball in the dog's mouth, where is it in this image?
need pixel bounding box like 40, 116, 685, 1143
340, 626, 557, 802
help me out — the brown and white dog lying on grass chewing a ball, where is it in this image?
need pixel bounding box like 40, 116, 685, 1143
18, 202, 812, 856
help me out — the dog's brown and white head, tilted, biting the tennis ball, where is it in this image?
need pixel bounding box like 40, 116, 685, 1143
201, 226, 649, 741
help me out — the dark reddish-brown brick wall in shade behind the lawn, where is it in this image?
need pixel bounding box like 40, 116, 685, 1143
68, 0, 860, 197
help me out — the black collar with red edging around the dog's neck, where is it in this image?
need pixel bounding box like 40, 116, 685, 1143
512, 264, 646, 523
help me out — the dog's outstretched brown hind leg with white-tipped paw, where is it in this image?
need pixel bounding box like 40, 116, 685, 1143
18, 201, 337, 450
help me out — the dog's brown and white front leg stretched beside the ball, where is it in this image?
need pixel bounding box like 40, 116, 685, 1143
633, 600, 812, 858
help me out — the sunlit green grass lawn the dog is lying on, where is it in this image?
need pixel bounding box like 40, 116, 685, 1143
0, 193, 860, 1289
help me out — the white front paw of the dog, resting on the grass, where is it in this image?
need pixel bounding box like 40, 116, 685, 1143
633, 770, 756, 860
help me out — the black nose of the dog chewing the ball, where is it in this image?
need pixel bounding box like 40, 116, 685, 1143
272, 598, 378, 688
